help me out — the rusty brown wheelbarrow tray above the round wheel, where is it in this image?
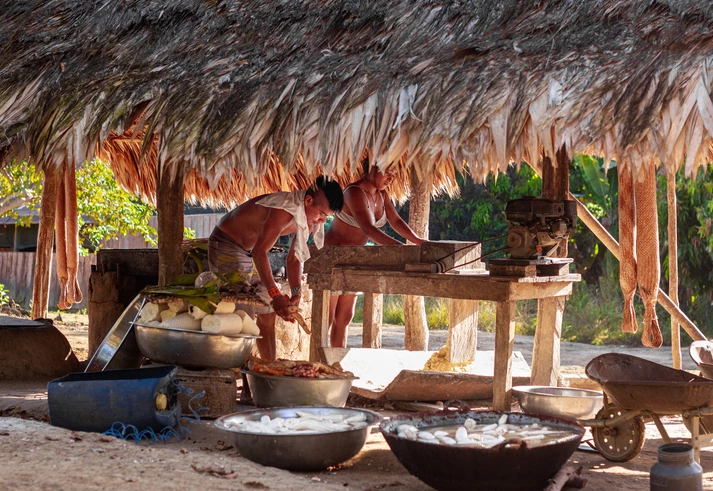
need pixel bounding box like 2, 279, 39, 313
586, 353, 713, 414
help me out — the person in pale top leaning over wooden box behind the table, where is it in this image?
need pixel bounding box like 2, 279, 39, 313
324, 160, 423, 348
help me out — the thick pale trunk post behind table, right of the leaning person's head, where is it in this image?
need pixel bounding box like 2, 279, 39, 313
404, 170, 432, 351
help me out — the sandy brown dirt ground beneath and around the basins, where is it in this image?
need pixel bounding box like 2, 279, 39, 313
0, 314, 713, 491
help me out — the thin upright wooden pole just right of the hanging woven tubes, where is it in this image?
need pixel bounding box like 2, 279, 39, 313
666, 170, 681, 370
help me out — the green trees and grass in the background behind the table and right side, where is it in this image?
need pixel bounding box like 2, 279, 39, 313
364, 160, 713, 345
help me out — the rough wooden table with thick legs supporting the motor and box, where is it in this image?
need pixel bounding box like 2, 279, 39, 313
306, 258, 581, 410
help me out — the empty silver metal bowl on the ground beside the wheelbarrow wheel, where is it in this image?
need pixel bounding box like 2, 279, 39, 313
512, 385, 604, 419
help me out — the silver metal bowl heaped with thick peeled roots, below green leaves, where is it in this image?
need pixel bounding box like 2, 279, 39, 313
134, 324, 260, 368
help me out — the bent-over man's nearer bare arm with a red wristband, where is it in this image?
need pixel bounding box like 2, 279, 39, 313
252, 208, 292, 320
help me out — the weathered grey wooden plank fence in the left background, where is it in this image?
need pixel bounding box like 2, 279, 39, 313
0, 213, 223, 309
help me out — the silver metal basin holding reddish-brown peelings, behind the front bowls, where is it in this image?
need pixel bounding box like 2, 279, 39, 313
241, 370, 356, 407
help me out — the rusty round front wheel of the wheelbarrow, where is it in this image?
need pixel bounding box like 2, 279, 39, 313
592, 404, 646, 462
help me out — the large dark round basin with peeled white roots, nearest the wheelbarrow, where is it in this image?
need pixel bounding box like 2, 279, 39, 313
380, 410, 584, 491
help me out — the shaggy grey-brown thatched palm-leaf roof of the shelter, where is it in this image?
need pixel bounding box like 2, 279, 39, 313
0, 0, 713, 205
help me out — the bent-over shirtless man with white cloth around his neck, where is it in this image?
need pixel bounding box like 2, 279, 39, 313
208, 176, 344, 361
